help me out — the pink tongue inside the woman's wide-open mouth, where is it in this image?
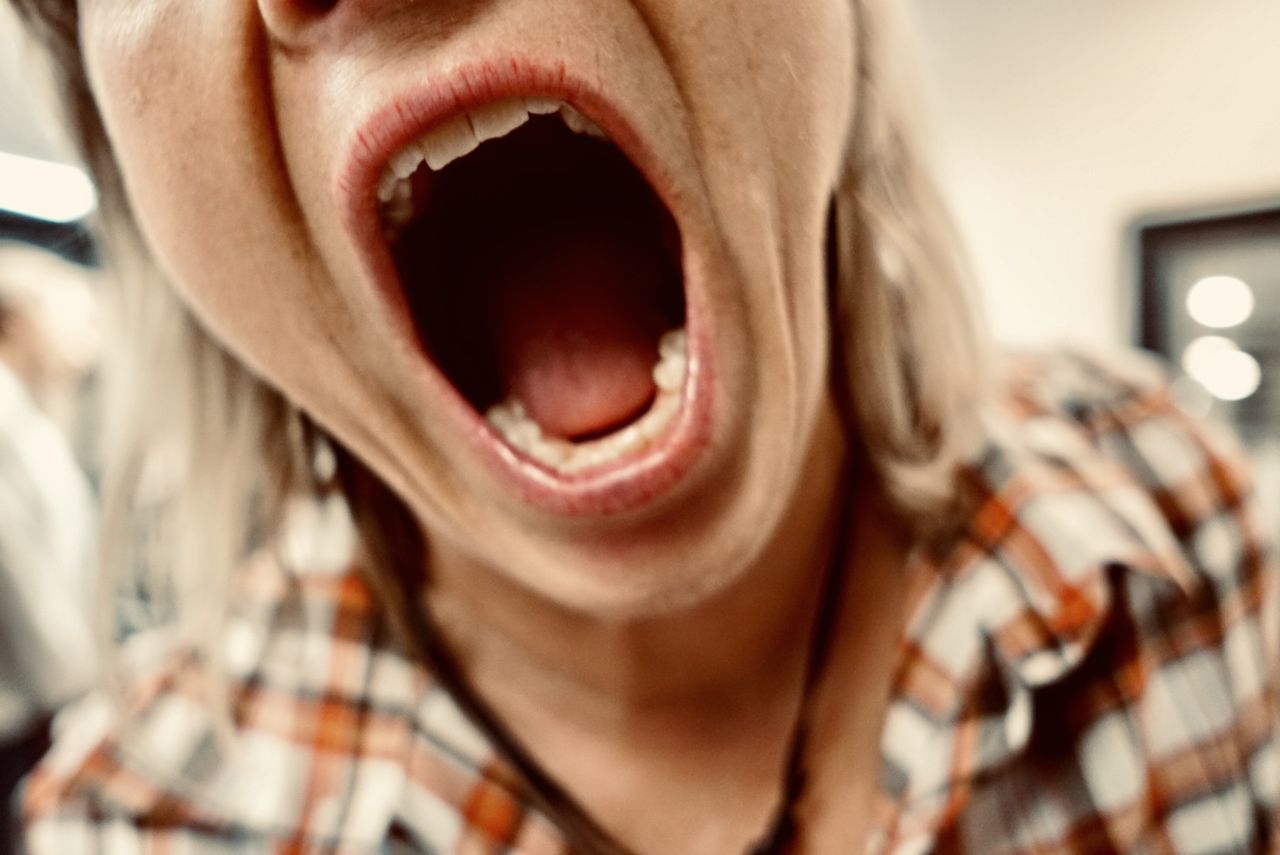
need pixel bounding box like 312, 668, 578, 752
488, 229, 667, 439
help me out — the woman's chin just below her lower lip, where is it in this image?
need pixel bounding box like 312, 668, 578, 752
421, 394, 804, 622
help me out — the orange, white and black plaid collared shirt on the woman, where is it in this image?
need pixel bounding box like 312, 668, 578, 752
26, 357, 1280, 855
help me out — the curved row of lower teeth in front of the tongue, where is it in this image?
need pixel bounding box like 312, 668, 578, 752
485, 329, 689, 475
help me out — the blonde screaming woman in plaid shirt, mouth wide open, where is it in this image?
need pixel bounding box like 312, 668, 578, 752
18, 0, 1277, 852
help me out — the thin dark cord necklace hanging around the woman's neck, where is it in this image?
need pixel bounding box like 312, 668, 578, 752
397, 501, 851, 855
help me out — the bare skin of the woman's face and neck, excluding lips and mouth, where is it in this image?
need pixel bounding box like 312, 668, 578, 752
81, 0, 901, 852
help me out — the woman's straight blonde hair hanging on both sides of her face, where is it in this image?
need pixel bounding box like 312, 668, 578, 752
13, 0, 983, 655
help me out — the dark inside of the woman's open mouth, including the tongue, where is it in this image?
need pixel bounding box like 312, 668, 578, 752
393, 116, 685, 442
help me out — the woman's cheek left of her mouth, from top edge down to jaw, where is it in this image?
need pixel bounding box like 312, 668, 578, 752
82, 0, 424, 506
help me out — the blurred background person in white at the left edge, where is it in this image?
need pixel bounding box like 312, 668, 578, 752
0, 243, 97, 852
